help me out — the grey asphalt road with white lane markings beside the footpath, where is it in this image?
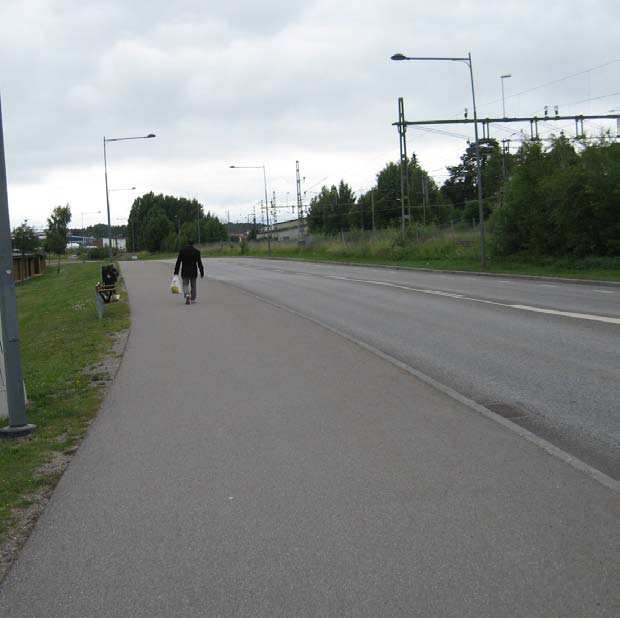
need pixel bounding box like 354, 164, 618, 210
207, 258, 620, 479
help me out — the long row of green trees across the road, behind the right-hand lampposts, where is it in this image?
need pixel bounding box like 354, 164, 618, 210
308, 136, 620, 256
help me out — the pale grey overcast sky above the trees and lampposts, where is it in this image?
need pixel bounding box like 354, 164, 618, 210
0, 0, 620, 227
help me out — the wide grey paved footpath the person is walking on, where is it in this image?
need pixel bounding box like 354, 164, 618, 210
0, 262, 620, 618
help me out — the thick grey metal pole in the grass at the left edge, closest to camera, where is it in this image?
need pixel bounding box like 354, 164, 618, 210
0, 95, 35, 437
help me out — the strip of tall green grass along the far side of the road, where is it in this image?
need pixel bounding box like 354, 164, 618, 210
201, 230, 620, 281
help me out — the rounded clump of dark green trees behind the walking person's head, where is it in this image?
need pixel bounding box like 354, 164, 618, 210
127, 193, 227, 252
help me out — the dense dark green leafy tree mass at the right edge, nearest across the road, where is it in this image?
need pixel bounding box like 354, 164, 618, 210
489, 137, 620, 257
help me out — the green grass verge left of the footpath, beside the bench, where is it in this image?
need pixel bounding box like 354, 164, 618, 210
0, 264, 129, 539
